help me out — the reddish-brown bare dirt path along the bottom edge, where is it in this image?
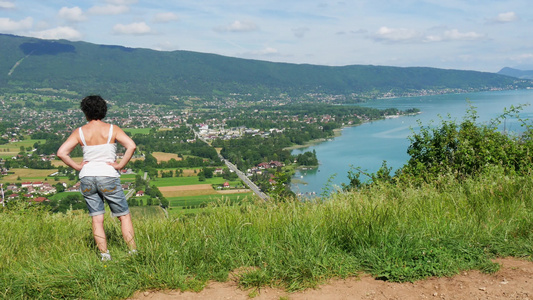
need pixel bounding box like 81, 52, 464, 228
130, 258, 533, 300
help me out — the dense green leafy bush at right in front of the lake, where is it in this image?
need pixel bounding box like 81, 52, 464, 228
397, 107, 533, 182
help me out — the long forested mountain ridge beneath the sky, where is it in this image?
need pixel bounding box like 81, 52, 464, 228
0, 34, 533, 103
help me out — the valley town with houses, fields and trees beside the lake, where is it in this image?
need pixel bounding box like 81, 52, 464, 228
0, 91, 417, 213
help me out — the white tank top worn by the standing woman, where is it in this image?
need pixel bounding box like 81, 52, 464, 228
79, 125, 120, 178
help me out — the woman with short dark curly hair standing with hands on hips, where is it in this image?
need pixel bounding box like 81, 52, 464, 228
57, 96, 137, 260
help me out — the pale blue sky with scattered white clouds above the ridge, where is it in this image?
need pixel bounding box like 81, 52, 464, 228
0, 0, 533, 72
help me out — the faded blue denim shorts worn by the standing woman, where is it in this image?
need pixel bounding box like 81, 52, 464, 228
80, 176, 130, 217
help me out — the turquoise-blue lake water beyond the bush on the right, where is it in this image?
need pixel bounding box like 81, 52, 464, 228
291, 90, 533, 195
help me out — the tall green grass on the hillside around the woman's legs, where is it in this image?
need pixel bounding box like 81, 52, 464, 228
0, 165, 533, 299
